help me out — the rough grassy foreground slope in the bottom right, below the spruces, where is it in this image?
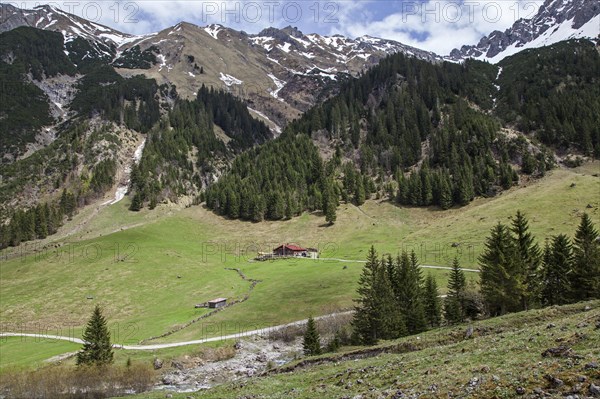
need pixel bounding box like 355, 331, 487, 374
126, 301, 600, 399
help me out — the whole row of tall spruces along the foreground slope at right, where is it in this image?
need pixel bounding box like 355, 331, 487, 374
352, 212, 600, 345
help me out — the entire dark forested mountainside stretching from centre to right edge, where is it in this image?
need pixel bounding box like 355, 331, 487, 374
206, 40, 600, 221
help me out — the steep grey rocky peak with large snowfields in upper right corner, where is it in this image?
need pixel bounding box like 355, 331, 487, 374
447, 0, 600, 63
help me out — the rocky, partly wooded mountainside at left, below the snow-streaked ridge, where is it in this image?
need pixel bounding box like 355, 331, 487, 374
0, 27, 272, 247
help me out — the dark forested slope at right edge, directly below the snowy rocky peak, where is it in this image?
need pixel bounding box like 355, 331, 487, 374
497, 39, 600, 158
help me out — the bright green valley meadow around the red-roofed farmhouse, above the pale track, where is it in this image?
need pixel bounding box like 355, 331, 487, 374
0, 163, 600, 363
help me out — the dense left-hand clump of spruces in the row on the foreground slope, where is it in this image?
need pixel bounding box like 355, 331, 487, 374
352, 247, 441, 345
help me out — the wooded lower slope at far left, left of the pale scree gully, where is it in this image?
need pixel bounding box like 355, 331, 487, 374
0, 124, 119, 248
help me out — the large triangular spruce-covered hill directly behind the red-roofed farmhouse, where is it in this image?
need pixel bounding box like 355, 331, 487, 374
209, 50, 554, 222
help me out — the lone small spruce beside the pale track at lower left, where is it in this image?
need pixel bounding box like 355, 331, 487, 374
77, 305, 113, 366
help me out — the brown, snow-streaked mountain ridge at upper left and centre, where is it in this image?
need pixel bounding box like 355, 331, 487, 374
0, 4, 442, 129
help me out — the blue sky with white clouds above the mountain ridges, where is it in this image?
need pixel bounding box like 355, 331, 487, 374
8, 0, 542, 55
